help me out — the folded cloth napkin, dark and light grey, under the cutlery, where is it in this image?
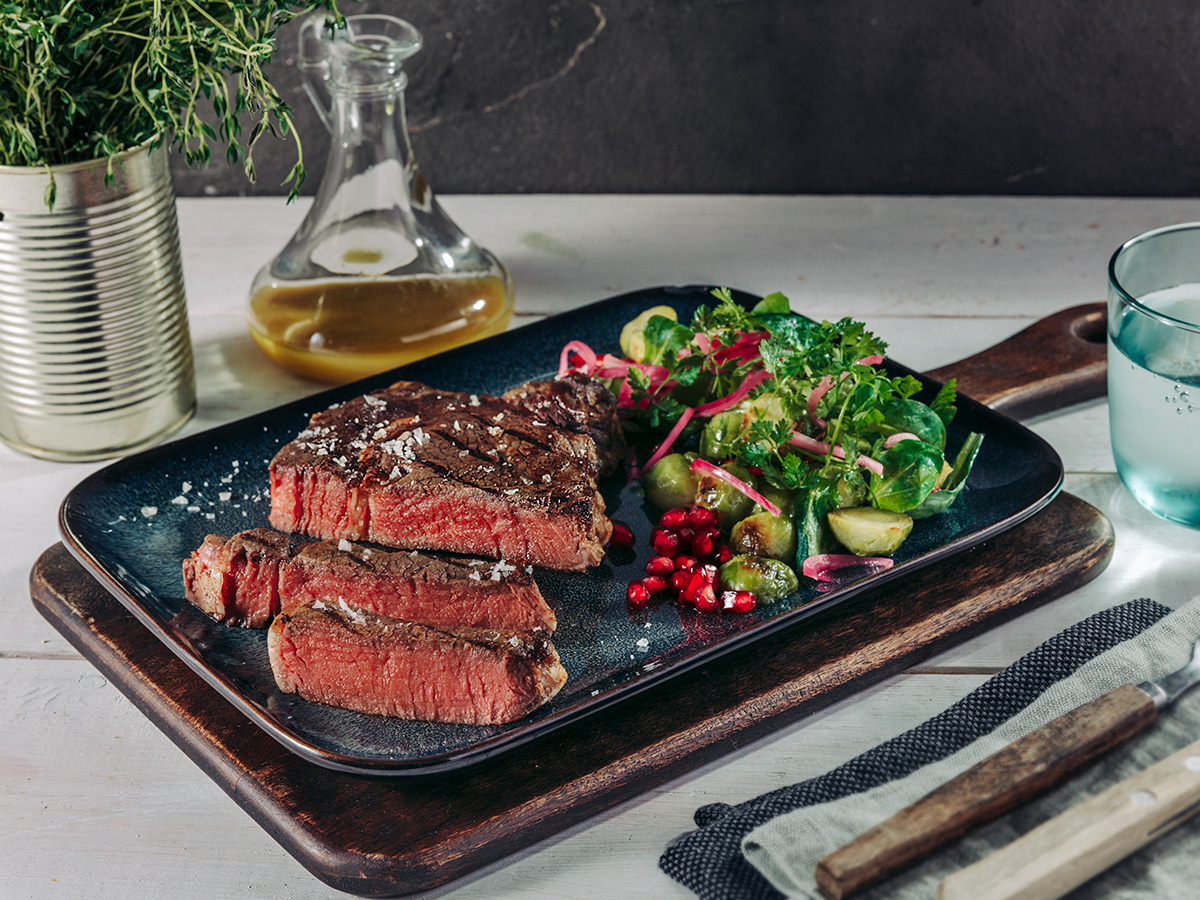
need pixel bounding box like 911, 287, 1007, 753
659, 598, 1200, 900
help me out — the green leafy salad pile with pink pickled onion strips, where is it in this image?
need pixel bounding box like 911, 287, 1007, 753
563, 288, 983, 585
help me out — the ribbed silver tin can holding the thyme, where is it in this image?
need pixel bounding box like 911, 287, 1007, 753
0, 146, 196, 461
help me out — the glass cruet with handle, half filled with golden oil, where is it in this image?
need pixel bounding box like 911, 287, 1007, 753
247, 13, 512, 382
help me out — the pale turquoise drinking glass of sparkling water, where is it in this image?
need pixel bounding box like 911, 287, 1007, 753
1108, 222, 1200, 528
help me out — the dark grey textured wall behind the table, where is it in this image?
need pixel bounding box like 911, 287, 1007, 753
169, 0, 1200, 196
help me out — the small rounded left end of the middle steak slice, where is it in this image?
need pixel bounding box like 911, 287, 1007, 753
184, 528, 299, 628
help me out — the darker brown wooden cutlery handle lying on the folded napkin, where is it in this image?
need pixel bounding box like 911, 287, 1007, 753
816, 684, 1157, 900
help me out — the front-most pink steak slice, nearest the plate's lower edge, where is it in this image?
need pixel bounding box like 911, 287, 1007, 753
266, 604, 566, 725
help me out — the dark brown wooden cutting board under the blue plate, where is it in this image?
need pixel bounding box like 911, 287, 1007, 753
30, 303, 1114, 896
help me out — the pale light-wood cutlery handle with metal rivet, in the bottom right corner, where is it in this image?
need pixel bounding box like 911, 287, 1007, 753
937, 740, 1200, 900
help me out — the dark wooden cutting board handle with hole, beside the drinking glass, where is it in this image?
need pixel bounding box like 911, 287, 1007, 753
926, 302, 1108, 419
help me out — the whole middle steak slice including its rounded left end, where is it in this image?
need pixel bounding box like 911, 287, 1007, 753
184, 528, 557, 632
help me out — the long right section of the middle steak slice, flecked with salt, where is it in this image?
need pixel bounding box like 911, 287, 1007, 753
280, 540, 558, 632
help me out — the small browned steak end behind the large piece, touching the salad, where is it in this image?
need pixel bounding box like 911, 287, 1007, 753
500, 372, 625, 474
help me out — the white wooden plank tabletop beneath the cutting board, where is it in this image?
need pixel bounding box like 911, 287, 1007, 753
0, 196, 1200, 900
